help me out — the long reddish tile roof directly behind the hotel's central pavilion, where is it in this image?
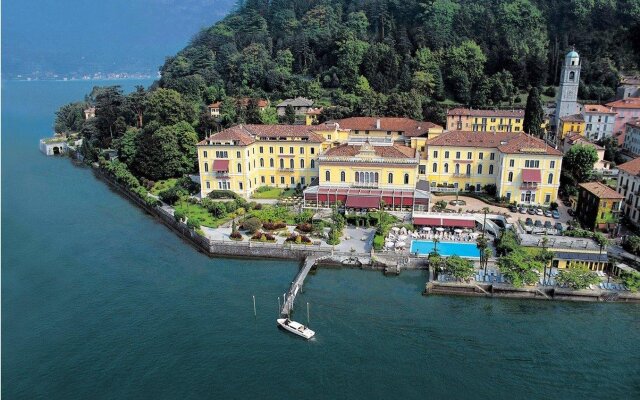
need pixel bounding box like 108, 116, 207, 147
336, 117, 442, 136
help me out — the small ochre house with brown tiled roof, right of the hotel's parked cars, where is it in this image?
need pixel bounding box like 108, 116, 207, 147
576, 182, 624, 232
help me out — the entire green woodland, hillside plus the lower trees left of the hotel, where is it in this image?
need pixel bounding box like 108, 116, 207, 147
55, 0, 640, 179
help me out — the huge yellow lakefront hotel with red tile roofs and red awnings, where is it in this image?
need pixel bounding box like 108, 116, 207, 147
198, 117, 562, 208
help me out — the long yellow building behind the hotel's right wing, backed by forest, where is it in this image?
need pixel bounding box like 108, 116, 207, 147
447, 108, 524, 132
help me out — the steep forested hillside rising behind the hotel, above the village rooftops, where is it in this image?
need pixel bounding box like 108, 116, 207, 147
160, 0, 640, 117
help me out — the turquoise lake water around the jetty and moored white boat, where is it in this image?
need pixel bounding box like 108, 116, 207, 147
1, 82, 640, 399
